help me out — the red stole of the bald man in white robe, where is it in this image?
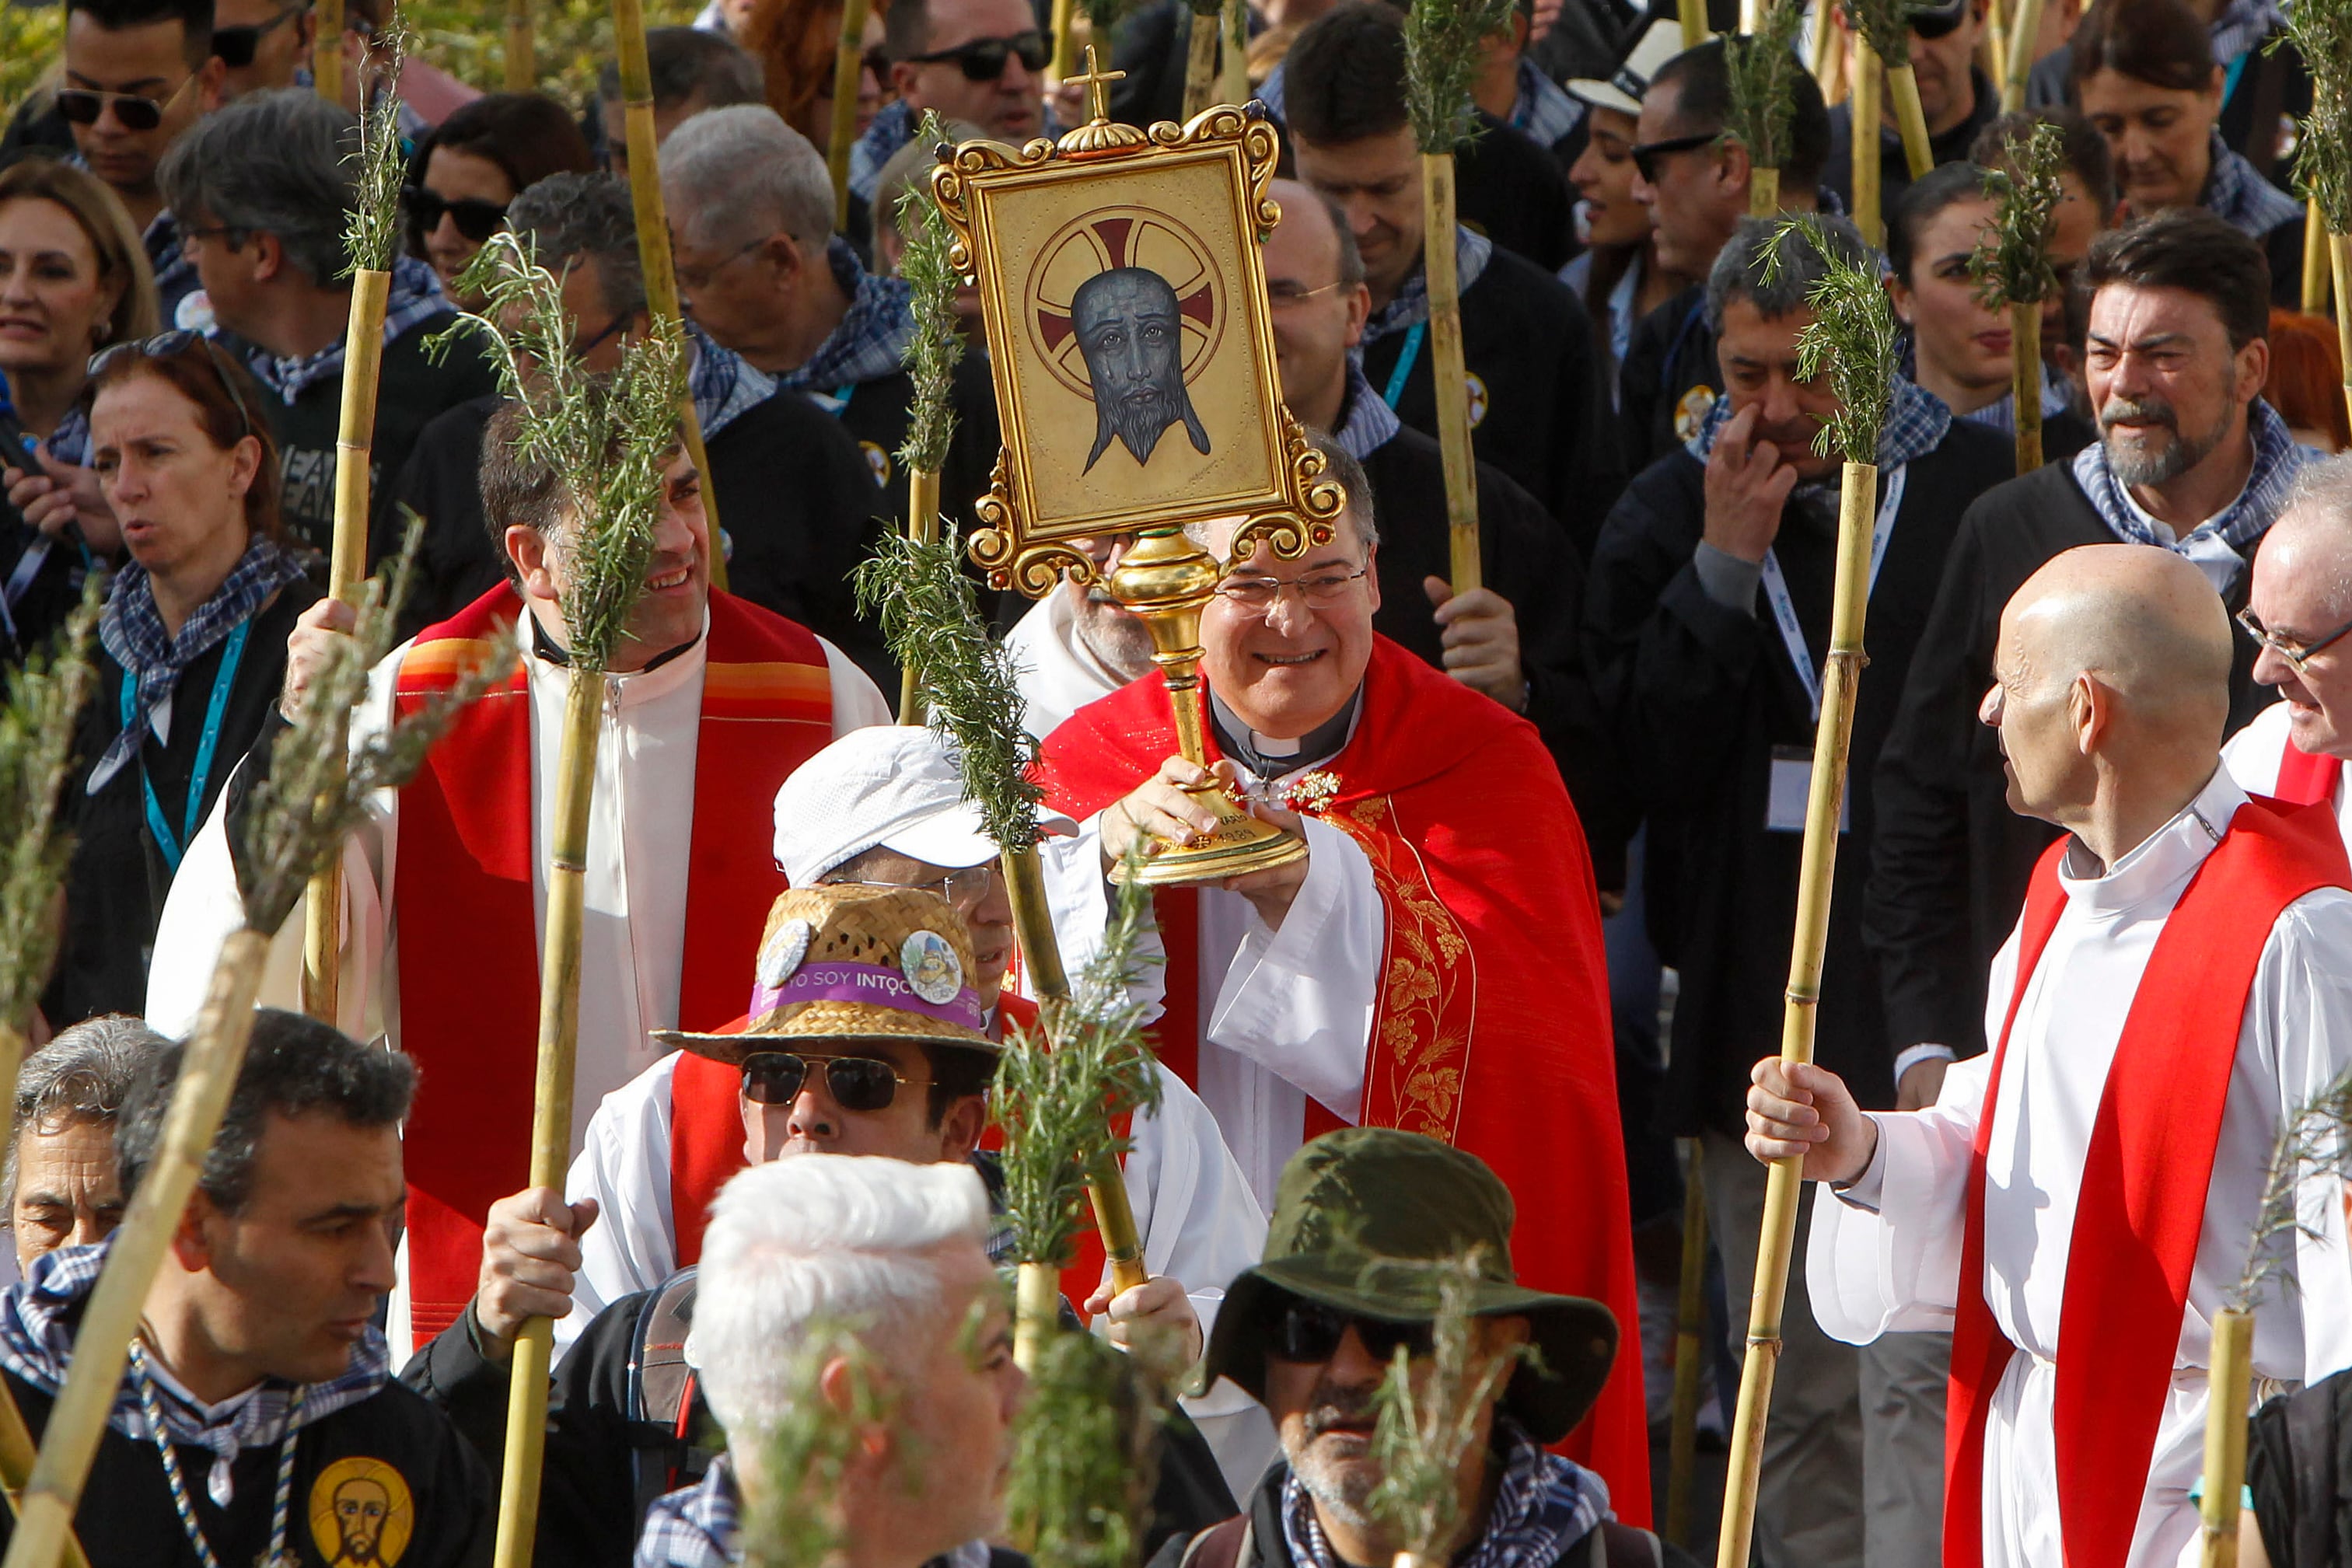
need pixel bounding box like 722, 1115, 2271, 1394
1943, 797, 2352, 1568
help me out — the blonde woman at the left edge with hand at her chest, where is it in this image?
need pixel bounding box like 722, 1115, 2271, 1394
0, 160, 156, 665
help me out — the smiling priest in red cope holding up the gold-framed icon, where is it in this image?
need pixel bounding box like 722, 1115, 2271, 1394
1042, 442, 1649, 1521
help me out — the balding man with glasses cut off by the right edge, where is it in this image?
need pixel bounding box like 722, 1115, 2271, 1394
2221, 456, 2352, 827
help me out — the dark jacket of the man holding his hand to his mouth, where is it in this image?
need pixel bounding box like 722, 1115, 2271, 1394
1585, 421, 2013, 1133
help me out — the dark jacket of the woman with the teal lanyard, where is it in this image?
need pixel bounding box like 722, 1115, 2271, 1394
42, 581, 317, 1027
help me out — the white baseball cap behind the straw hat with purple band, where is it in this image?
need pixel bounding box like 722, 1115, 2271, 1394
776, 724, 1077, 886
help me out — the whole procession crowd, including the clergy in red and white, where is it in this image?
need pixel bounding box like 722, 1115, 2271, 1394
0, 0, 2352, 1568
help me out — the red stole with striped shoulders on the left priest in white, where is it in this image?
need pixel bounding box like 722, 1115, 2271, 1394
395, 588, 833, 1345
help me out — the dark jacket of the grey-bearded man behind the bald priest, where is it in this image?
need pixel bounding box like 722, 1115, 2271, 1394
1854, 463, 2277, 1056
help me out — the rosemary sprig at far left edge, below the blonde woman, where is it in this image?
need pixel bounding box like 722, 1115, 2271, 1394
0, 571, 106, 1030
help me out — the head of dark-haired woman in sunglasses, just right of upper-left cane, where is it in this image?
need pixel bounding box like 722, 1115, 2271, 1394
402, 92, 595, 294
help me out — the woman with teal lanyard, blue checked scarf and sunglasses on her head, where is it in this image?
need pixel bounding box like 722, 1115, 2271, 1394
42, 331, 317, 1025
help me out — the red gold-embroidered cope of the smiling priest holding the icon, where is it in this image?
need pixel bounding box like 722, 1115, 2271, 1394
1040, 637, 1649, 1524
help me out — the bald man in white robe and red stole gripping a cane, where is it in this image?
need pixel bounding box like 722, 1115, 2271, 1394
1748, 546, 2352, 1568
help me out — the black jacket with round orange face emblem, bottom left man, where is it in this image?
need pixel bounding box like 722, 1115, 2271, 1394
0, 1373, 494, 1568
